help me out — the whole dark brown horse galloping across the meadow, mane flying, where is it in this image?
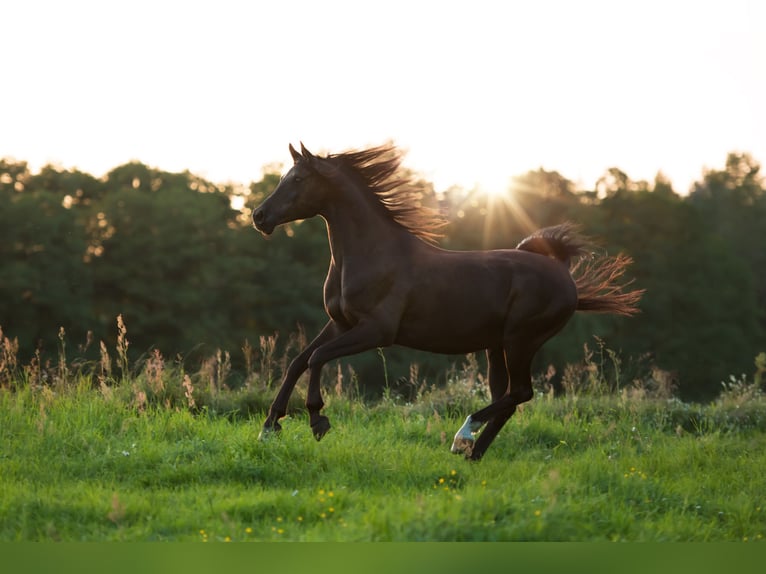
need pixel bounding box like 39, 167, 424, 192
253, 144, 641, 459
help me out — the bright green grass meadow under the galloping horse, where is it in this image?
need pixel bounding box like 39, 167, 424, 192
0, 378, 766, 542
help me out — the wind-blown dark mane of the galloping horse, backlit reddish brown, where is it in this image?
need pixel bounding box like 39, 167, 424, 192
326, 144, 446, 243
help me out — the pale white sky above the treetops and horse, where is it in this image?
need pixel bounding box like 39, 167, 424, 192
0, 0, 766, 193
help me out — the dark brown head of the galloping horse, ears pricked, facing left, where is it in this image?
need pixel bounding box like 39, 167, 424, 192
253, 143, 331, 235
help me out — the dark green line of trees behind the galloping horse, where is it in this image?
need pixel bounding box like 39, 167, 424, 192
0, 153, 766, 399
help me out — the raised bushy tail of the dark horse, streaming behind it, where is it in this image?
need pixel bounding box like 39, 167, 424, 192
516, 223, 644, 316
